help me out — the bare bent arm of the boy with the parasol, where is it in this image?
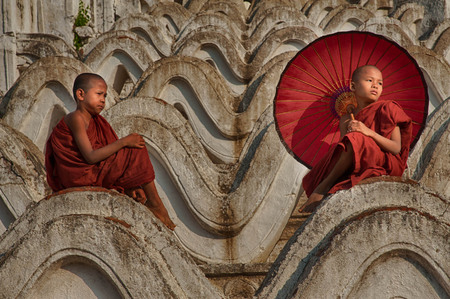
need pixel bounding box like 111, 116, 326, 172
348, 120, 402, 155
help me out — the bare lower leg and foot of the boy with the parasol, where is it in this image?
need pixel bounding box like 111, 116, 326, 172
299, 142, 353, 213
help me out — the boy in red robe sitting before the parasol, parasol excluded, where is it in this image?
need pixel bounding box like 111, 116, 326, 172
300, 65, 412, 212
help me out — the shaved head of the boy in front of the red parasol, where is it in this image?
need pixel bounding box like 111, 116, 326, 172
351, 66, 383, 104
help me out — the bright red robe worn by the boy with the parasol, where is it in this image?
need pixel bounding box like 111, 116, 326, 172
303, 101, 412, 197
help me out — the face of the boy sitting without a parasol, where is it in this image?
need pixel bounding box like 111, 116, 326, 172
78, 79, 107, 115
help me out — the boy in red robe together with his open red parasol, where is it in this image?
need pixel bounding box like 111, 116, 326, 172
274, 31, 428, 212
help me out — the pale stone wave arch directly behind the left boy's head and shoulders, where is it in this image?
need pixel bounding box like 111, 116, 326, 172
0, 57, 117, 151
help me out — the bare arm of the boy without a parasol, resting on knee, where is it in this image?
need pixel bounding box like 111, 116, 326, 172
66, 114, 145, 164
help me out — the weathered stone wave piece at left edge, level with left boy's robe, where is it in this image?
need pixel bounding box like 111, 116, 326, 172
0, 120, 51, 234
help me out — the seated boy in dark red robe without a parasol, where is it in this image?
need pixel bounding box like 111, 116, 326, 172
45, 73, 175, 230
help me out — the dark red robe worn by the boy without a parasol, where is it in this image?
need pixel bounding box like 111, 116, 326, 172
45, 115, 155, 192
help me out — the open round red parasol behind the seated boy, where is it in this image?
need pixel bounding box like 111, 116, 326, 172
274, 31, 428, 168
